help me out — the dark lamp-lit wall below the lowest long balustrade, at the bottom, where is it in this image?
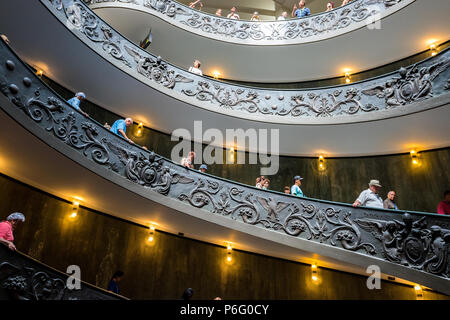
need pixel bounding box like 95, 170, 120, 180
0, 175, 449, 300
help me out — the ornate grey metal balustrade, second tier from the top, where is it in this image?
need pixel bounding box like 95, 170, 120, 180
41, 0, 450, 124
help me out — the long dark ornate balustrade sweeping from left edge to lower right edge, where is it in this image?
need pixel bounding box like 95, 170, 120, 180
0, 38, 450, 294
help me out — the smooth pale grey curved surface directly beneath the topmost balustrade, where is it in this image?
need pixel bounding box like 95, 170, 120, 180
91, 0, 450, 83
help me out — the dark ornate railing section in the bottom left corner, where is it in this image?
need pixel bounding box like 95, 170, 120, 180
0, 244, 125, 300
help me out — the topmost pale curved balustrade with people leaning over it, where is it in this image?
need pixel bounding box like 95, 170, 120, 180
84, 0, 414, 45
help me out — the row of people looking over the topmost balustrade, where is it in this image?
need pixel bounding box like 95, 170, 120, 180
185, 0, 352, 21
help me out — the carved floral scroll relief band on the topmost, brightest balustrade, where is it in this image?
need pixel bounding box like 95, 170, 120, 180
84, 0, 404, 42
